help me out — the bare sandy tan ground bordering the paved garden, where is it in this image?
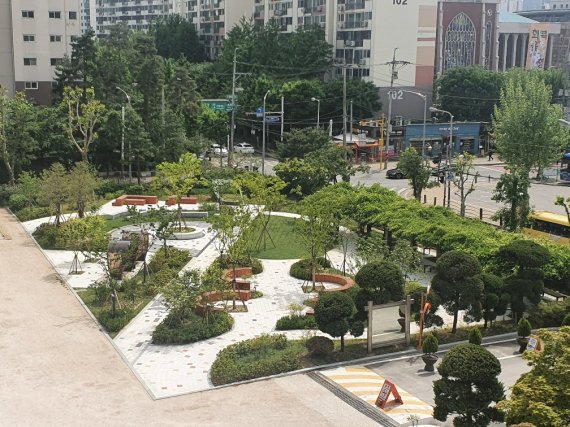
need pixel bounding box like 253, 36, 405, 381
0, 209, 377, 427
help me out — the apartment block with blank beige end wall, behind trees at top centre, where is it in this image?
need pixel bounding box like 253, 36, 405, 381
186, 0, 254, 59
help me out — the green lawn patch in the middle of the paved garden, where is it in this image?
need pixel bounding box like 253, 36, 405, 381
252, 216, 307, 259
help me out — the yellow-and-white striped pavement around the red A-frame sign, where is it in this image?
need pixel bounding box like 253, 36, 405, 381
320, 366, 433, 424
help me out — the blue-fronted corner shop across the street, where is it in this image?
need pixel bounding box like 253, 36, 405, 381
404, 122, 481, 157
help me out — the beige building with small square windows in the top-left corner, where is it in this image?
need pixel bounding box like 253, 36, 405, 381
0, 0, 81, 104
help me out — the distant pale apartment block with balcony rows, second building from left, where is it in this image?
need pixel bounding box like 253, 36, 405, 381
93, 0, 186, 36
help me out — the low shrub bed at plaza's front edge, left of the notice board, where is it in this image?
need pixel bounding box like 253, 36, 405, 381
210, 335, 306, 385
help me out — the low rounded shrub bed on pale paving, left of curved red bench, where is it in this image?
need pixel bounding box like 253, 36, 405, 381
152, 311, 234, 344
